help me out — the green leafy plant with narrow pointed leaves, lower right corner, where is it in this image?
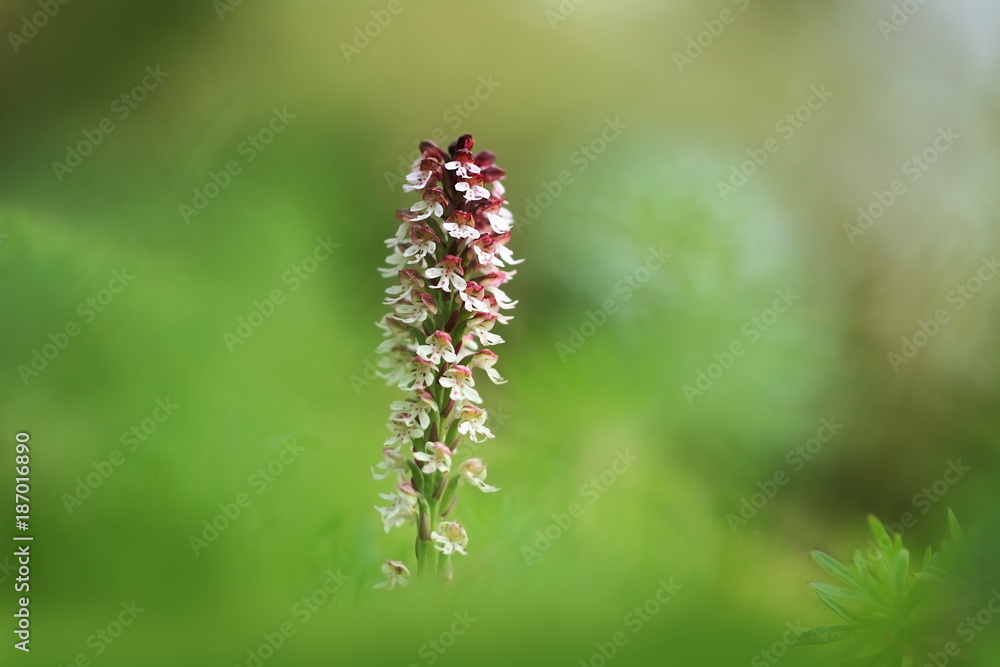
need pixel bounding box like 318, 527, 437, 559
796, 510, 979, 667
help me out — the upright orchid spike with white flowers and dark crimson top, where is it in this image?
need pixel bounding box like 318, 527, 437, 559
372, 134, 520, 589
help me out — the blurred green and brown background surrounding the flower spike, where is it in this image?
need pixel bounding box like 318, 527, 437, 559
0, 0, 1000, 667
